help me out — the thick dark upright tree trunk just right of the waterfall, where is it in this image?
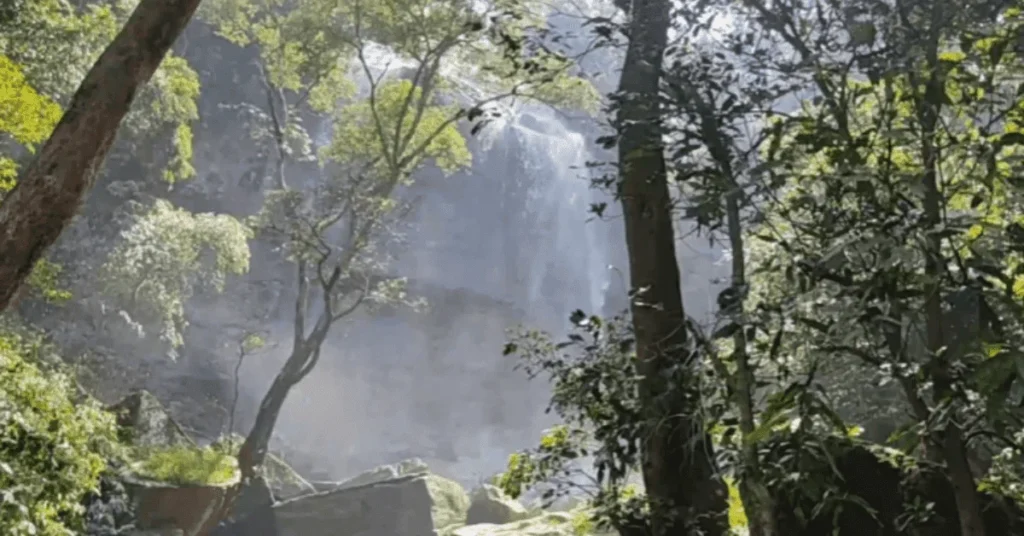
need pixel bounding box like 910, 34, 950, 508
616, 0, 728, 536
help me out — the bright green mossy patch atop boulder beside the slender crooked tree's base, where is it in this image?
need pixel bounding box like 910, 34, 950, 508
134, 446, 238, 486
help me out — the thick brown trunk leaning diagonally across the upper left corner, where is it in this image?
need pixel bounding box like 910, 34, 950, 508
0, 0, 200, 312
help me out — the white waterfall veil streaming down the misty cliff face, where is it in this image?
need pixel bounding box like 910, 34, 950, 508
399, 107, 614, 317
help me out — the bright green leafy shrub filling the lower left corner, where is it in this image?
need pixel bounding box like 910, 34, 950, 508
0, 326, 122, 536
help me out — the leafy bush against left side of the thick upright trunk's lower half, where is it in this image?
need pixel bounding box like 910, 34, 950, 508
499, 311, 647, 530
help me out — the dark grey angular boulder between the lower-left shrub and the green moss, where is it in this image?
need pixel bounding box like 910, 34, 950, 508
108, 390, 196, 447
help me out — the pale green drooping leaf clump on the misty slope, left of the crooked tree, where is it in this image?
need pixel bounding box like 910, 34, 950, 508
102, 201, 251, 346
